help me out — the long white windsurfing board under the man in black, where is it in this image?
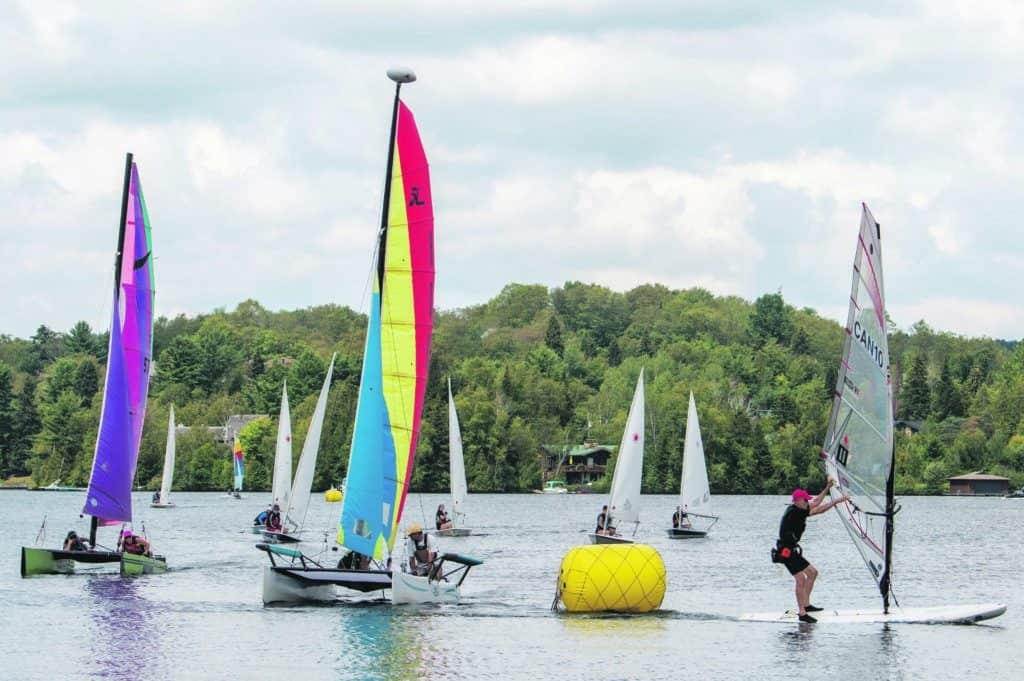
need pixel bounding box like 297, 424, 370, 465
739, 603, 1007, 625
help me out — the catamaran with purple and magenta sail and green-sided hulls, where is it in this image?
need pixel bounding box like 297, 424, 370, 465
22, 154, 167, 577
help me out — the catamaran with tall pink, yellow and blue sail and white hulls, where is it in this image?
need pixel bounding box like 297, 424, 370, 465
257, 69, 479, 603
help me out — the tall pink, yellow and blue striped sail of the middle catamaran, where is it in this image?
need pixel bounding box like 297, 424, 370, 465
338, 99, 434, 560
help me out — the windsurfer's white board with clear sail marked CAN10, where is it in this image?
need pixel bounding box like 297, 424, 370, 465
741, 205, 1007, 624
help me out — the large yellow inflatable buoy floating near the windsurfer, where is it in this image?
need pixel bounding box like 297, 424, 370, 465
558, 544, 666, 612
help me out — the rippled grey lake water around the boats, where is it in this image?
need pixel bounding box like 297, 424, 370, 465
0, 492, 1024, 681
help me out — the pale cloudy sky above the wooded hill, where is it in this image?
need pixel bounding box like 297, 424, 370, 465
0, 0, 1024, 339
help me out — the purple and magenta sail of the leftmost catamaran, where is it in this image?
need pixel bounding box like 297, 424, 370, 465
83, 155, 154, 524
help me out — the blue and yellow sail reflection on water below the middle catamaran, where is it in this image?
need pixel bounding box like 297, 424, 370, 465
336, 605, 455, 680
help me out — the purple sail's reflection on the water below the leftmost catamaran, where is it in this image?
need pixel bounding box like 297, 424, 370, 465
85, 576, 160, 681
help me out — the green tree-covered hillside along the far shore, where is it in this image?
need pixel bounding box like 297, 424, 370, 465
0, 282, 1024, 494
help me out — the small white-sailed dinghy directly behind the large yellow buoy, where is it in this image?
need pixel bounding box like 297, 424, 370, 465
587, 369, 644, 544
